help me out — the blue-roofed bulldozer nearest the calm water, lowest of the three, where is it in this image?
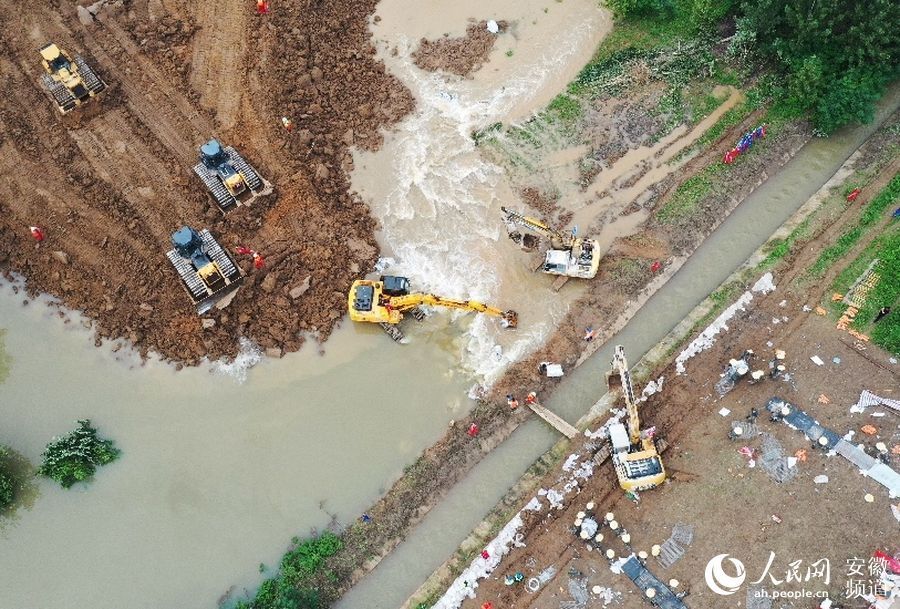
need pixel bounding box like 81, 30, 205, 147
166, 226, 244, 315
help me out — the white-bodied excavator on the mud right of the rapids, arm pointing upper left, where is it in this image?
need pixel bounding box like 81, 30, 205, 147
500, 207, 600, 279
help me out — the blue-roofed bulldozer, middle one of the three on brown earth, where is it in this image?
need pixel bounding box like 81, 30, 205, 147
194, 139, 269, 213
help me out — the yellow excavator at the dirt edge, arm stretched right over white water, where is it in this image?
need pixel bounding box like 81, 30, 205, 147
347, 275, 519, 342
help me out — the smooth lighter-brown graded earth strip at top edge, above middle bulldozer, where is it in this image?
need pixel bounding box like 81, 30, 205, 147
190, 0, 249, 130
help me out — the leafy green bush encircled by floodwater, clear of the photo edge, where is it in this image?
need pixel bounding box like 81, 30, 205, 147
38, 419, 121, 488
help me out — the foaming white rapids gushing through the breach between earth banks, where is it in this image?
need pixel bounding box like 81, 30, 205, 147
354, 13, 598, 384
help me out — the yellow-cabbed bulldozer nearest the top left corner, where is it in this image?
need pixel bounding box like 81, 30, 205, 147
40, 42, 106, 114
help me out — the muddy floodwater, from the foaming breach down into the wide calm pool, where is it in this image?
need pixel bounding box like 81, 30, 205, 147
0, 0, 607, 609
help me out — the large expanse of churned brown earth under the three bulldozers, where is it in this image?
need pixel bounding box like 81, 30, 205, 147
0, 0, 413, 364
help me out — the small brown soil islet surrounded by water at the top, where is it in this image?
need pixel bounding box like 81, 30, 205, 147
412, 21, 508, 76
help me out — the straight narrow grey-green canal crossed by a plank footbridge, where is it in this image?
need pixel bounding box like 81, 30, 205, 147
336, 87, 900, 609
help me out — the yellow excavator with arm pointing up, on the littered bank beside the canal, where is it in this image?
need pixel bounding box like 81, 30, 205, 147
606, 345, 666, 492
